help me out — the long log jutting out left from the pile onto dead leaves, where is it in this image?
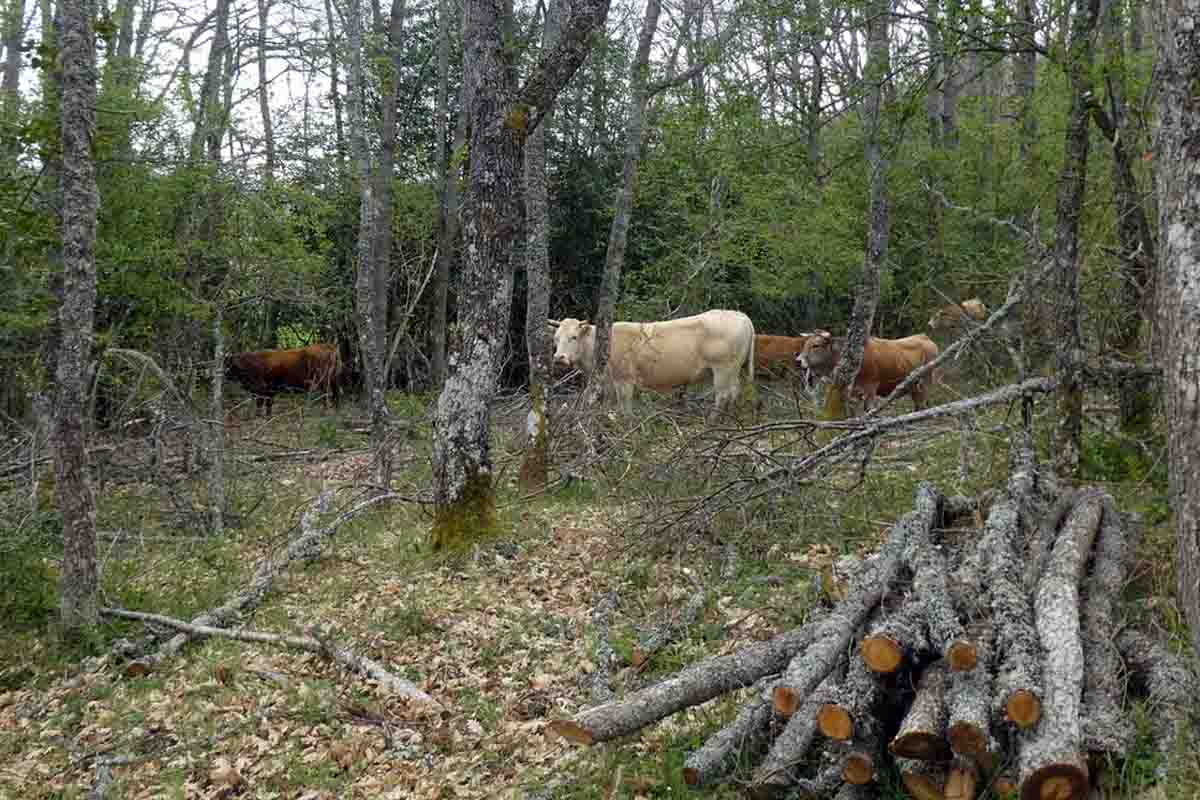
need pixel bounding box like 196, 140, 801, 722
550, 616, 823, 745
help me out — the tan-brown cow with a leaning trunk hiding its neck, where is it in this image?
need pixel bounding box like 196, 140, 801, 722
797, 331, 937, 411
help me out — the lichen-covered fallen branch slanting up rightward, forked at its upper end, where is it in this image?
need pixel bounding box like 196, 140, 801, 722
127, 492, 400, 674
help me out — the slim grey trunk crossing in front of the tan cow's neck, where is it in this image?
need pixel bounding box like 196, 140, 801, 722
824, 0, 890, 420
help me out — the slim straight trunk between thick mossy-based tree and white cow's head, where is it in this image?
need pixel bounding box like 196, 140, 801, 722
521, 0, 563, 492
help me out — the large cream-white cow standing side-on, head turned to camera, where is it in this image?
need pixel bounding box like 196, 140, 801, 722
547, 309, 755, 414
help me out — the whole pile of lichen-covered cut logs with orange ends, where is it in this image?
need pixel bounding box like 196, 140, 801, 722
551, 450, 1196, 800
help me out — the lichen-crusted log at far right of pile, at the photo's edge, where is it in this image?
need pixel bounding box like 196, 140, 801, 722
1117, 628, 1200, 780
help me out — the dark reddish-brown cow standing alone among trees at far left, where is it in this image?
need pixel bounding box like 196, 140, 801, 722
226, 344, 342, 416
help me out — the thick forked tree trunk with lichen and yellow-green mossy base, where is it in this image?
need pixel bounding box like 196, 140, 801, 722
432, 0, 610, 549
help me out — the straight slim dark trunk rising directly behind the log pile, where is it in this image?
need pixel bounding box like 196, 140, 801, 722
1054, 0, 1099, 476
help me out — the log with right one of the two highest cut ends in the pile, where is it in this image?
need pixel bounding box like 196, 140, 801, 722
904, 483, 976, 672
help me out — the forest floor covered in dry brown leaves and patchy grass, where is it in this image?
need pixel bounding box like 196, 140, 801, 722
0, 376, 1200, 800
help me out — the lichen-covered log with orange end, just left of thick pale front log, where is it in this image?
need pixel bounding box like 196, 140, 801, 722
983, 500, 1042, 728
